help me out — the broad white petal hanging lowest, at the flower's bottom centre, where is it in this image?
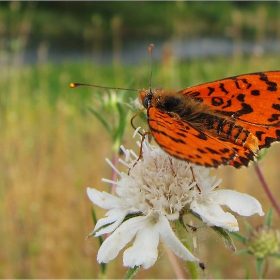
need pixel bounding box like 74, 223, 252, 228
123, 219, 159, 269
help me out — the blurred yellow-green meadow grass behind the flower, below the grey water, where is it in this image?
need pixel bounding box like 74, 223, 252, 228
0, 50, 280, 278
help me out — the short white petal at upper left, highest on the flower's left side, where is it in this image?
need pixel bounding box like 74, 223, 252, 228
87, 188, 121, 209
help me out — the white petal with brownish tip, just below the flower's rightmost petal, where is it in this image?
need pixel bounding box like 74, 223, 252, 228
190, 201, 239, 231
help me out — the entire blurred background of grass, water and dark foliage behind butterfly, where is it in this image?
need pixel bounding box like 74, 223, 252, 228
0, 1, 280, 278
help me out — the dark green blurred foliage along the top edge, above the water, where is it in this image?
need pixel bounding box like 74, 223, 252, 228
0, 1, 279, 50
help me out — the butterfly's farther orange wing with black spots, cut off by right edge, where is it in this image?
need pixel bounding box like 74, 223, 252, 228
180, 71, 280, 149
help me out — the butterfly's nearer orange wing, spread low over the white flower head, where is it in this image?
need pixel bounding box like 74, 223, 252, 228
147, 107, 254, 167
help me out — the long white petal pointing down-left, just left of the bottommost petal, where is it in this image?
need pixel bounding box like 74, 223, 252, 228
97, 216, 145, 263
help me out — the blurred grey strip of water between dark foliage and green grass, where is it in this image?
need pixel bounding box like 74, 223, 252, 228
19, 38, 280, 64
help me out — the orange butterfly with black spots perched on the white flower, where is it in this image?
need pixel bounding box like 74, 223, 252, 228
140, 71, 280, 168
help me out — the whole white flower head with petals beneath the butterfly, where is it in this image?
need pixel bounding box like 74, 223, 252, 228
87, 133, 263, 269
